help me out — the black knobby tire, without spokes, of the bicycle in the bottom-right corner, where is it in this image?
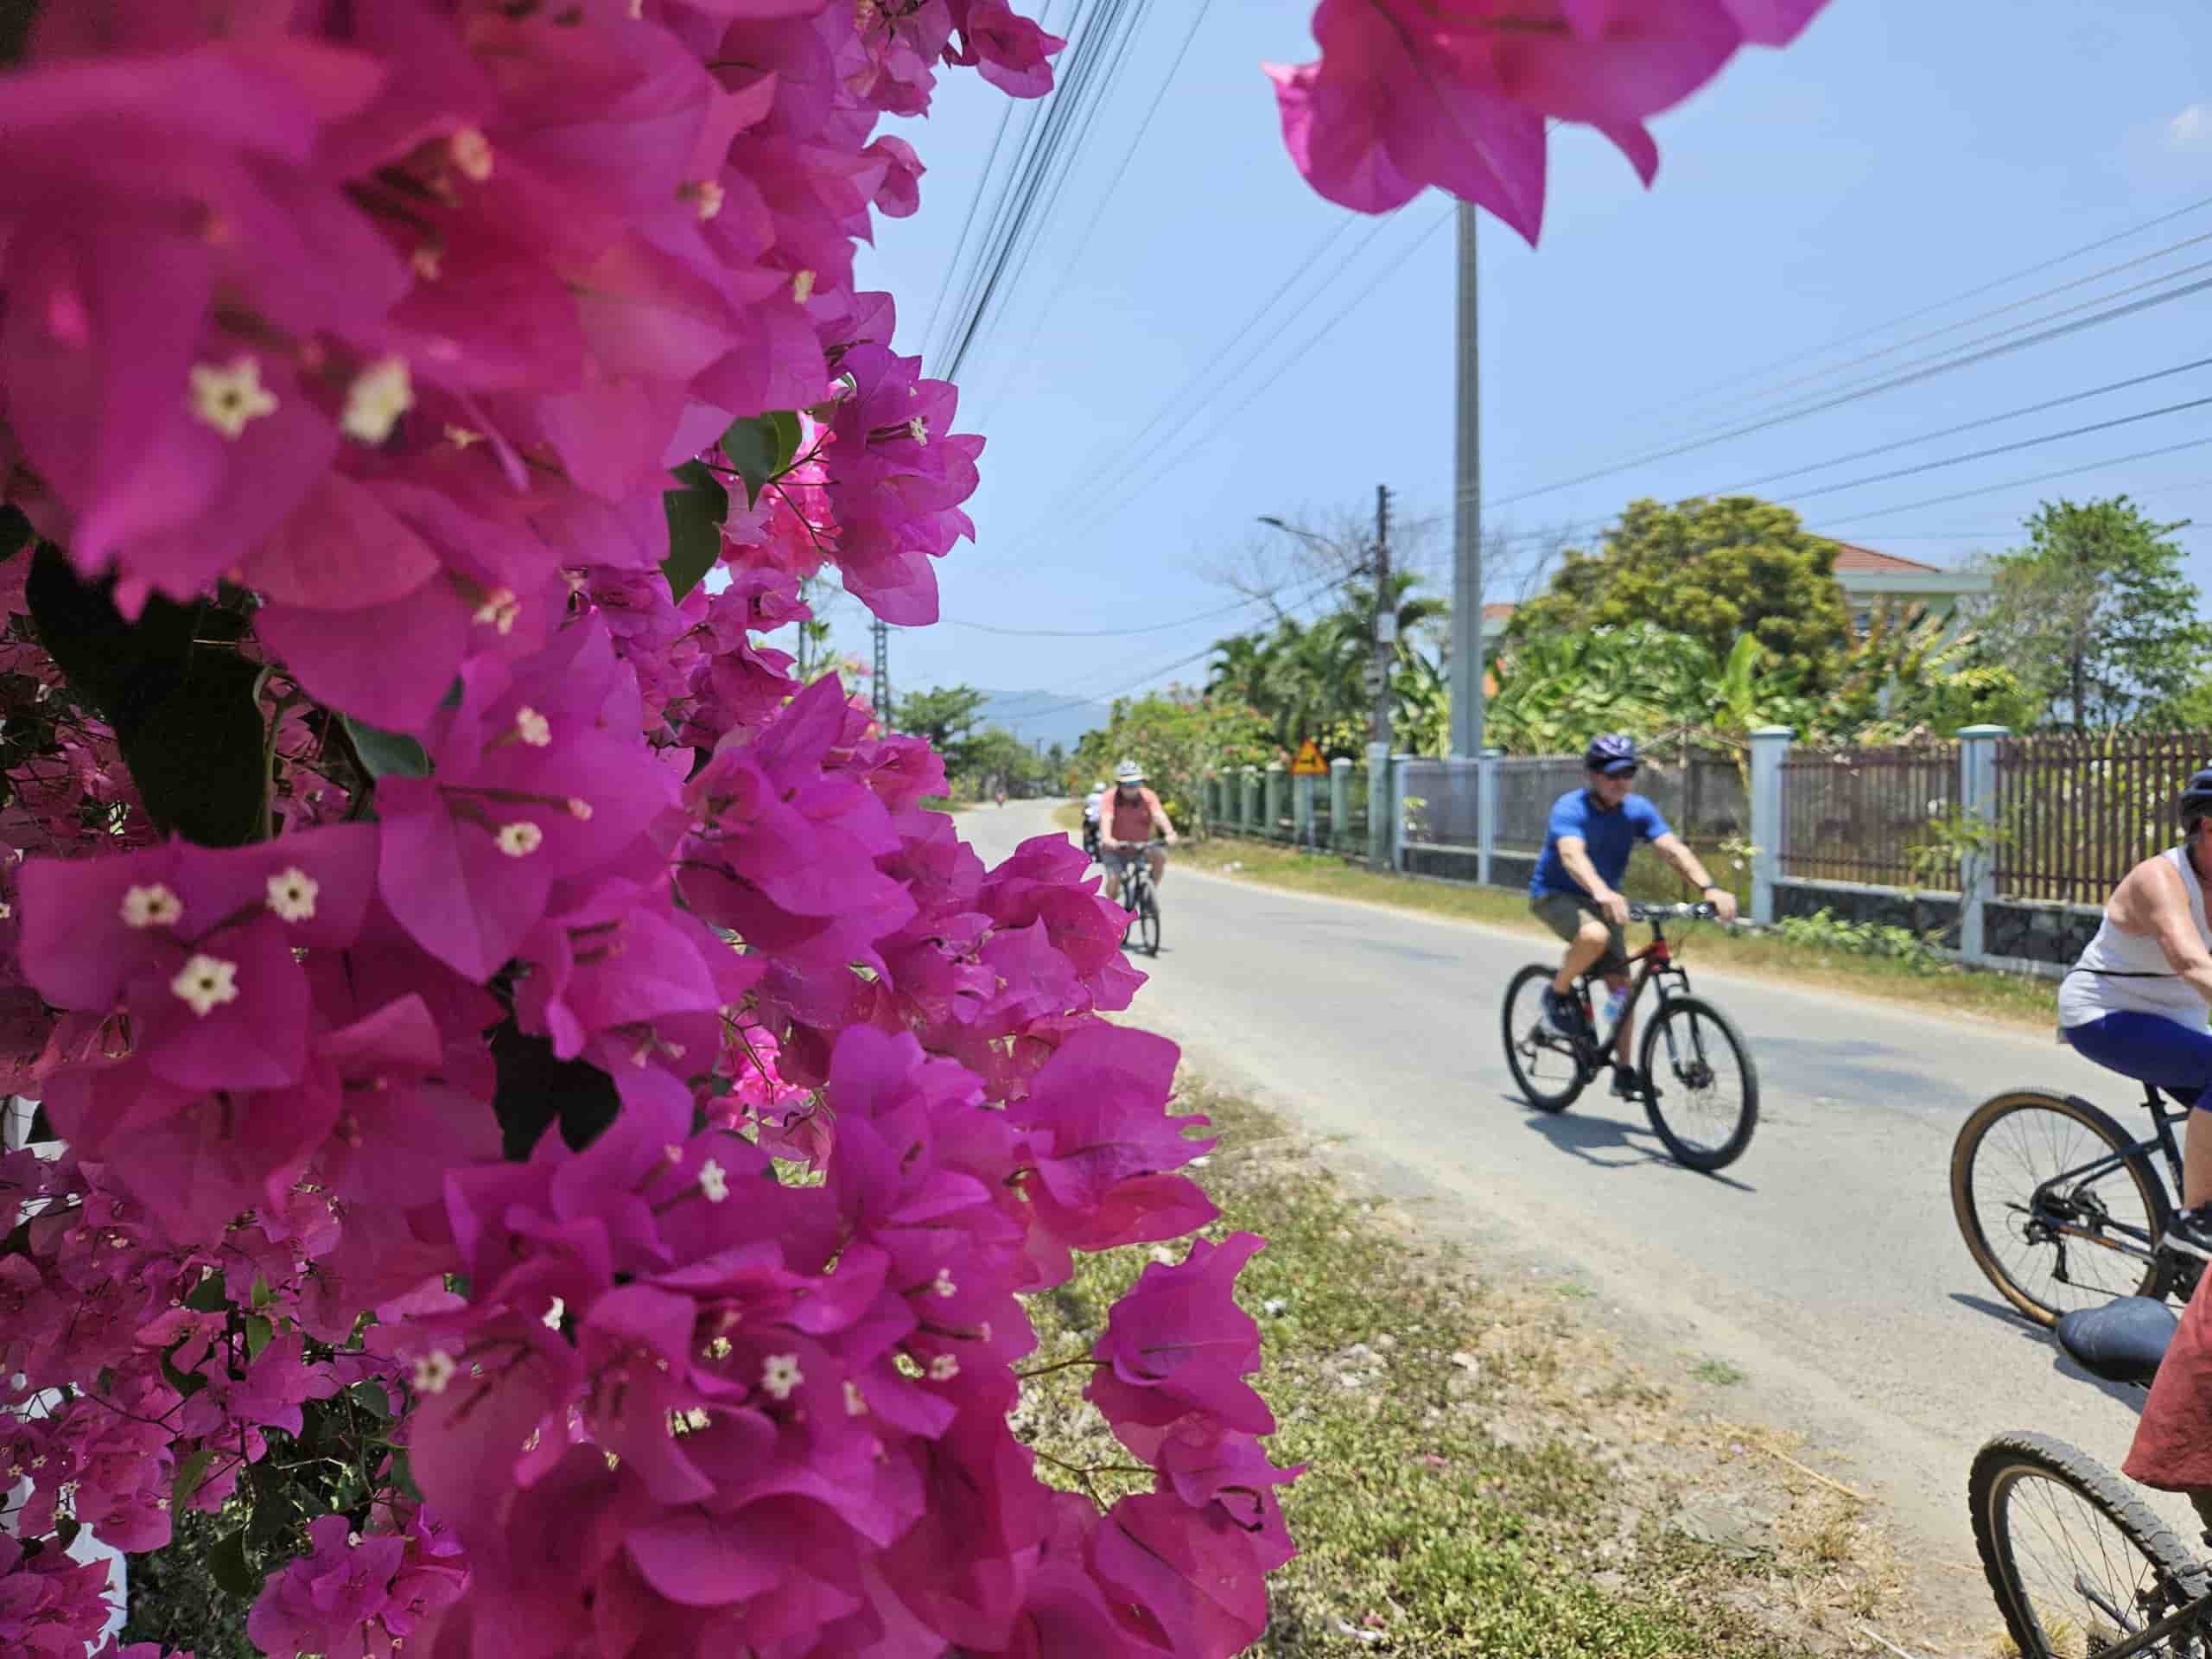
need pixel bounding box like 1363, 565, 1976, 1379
1967, 1433, 2208, 1659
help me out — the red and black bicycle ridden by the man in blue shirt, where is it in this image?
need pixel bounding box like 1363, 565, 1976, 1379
1504, 905, 1758, 1174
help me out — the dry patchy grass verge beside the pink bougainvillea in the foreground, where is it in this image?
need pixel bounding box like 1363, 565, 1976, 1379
1015, 1090, 1900, 1659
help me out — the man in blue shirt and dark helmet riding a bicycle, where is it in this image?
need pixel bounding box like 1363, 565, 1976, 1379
1529, 732, 1737, 1099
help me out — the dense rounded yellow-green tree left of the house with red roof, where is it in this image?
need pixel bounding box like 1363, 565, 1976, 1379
1509, 495, 1852, 690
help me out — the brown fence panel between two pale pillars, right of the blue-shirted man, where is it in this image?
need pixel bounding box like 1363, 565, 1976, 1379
1781, 743, 1958, 887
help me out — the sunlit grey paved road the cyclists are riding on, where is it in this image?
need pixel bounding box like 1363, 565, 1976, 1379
960, 803, 2192, 1608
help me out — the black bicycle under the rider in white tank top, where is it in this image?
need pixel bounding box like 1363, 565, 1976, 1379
1951, 1084, 2199, 1325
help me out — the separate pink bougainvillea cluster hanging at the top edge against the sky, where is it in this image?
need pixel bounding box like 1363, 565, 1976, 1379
1268, 0, 1827, 244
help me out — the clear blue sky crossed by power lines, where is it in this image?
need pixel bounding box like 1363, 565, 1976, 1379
832, 0, 2212, 716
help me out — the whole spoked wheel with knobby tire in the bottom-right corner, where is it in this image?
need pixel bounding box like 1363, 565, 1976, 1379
1967, 1433, 2212, 1659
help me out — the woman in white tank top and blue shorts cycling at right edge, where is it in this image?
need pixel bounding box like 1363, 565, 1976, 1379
2059, 767, 2212, 1261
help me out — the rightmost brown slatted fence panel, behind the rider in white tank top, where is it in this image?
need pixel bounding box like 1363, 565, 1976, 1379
1993, 732, 2212, 905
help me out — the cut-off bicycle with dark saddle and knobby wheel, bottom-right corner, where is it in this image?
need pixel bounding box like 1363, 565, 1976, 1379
1967, 1296, 2212, 1659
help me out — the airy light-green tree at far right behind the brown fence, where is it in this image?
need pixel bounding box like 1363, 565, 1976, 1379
1975, 495, 2212, 732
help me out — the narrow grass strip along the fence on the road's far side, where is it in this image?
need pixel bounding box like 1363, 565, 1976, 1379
1185, 836, 2057, 1028
